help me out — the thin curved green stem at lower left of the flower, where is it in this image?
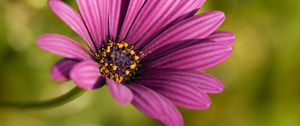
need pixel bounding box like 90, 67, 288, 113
0, 87, 85, 109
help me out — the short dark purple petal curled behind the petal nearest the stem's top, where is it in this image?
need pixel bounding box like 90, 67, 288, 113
51, 59, 80, 81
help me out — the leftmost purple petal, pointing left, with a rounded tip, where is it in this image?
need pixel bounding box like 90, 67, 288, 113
37, 34, 93, 60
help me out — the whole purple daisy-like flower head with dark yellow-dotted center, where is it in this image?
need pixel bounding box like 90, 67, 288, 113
37, 0, 235, 126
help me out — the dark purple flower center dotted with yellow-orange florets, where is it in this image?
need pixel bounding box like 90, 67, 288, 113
96, 40, 143, 83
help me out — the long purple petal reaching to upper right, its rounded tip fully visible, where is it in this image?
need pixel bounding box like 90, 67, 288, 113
141, 11, 224, 55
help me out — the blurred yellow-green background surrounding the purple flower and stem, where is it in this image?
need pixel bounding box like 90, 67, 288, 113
0, 0, 300, 126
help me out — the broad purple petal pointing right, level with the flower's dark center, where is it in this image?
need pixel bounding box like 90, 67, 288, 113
144, 43, 232, 70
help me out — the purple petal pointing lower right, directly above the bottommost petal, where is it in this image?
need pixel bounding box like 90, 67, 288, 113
138, 75, 210, 110
